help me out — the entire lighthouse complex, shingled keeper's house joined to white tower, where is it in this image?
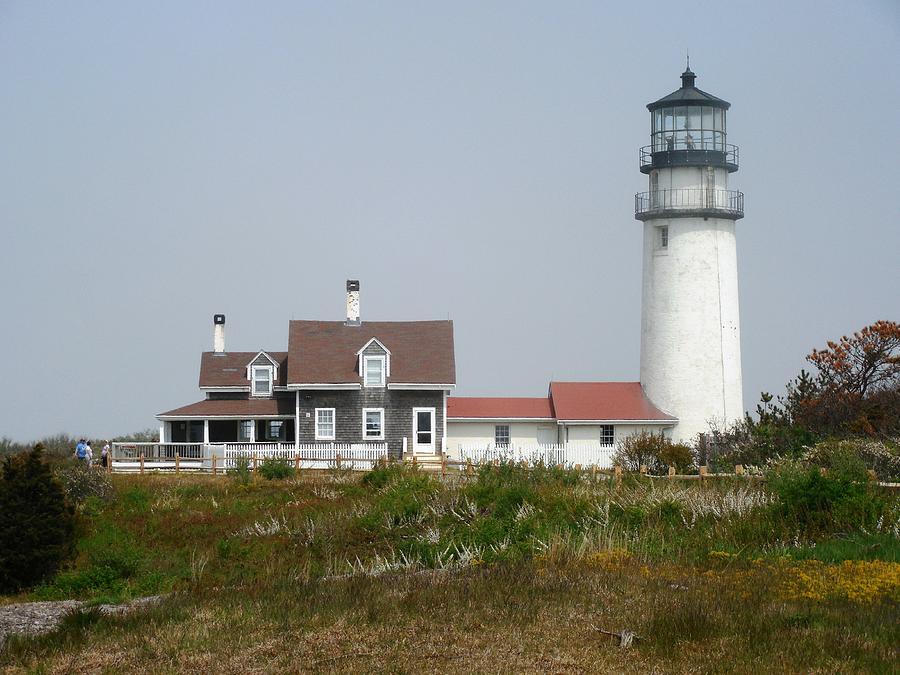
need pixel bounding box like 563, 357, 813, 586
158, 67, 744, 464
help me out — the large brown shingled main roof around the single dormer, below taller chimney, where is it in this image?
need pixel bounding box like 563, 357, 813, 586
287, 321, 456, 385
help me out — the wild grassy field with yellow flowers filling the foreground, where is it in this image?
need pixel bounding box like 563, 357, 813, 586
0, 466, 900, 673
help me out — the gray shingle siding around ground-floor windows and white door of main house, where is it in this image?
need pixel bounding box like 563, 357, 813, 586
300, 387, 444, 457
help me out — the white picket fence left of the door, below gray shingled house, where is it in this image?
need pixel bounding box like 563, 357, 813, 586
220, 443, 388, 471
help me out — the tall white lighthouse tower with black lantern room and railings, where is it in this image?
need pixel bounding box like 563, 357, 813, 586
634, 66, 744, 440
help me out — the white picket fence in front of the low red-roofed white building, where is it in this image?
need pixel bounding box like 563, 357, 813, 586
449, 441, 616, 469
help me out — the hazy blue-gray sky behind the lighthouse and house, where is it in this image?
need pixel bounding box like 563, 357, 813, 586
0, 0, 900, 440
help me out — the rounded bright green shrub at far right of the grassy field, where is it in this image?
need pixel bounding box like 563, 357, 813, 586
769, 447, 885, 532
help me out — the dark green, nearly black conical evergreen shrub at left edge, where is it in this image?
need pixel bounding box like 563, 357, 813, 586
0, 444, 75, 592
